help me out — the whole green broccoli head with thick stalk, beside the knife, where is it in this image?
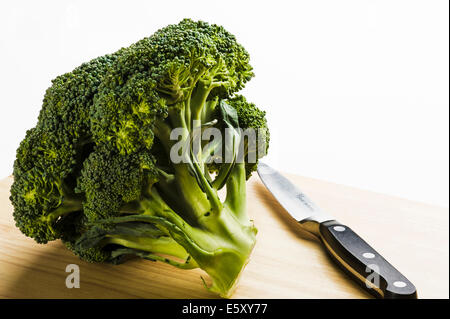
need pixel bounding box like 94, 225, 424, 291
10, 19, 270, 297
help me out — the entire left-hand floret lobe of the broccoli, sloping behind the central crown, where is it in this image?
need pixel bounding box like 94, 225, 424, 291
10, 51, 120, 243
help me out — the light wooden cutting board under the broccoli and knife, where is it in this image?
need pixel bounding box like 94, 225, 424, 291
0, 175, 449, 298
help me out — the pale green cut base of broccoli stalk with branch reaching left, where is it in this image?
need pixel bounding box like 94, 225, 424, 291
110, 204, 256, 297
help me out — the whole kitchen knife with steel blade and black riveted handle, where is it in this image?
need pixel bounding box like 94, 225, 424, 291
258, 162, 417, 299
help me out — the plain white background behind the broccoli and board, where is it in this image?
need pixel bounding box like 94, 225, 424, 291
0, 0, 449, 207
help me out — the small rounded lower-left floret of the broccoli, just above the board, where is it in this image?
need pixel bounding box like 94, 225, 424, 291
10, 128, 82, 243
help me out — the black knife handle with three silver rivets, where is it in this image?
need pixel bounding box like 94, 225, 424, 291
319, 220, 417, 299
